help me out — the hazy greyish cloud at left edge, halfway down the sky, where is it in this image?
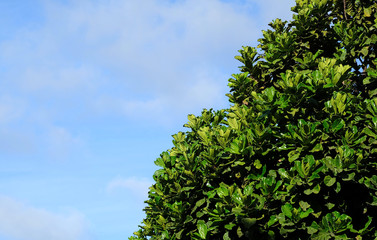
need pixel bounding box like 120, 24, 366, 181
0, 106, 85, 160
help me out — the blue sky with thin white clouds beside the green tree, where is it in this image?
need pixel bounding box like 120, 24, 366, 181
0, 0, 294, 240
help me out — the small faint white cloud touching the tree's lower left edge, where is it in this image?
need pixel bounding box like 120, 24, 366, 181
107, 177, 153, 199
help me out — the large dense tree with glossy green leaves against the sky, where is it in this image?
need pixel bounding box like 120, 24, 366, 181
130, 0, 377, 239
